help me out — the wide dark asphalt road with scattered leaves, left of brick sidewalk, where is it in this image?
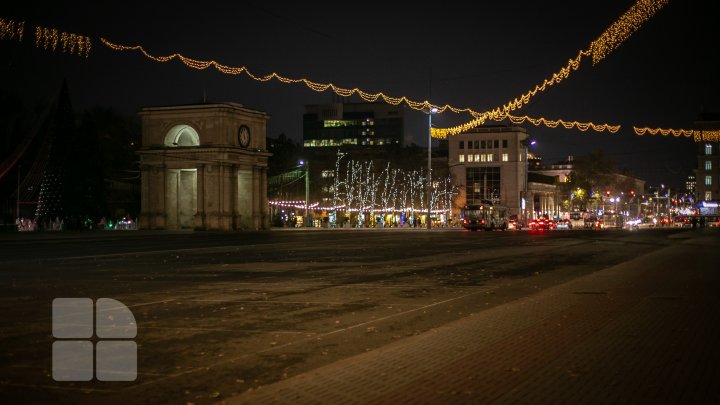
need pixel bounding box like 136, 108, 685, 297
0, 229, 708, 404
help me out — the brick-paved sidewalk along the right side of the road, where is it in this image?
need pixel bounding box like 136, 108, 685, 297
223, 230, 720, 404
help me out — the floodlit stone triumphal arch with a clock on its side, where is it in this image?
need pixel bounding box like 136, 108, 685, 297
138, 103, 270, 231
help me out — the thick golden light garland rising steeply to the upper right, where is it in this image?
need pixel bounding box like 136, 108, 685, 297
434, 0, 668, 138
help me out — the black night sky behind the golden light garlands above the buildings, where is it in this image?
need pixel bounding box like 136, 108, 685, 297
0, 0, 720, 186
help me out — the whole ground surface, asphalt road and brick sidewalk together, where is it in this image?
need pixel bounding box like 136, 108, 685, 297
0, 228, 720, 404
